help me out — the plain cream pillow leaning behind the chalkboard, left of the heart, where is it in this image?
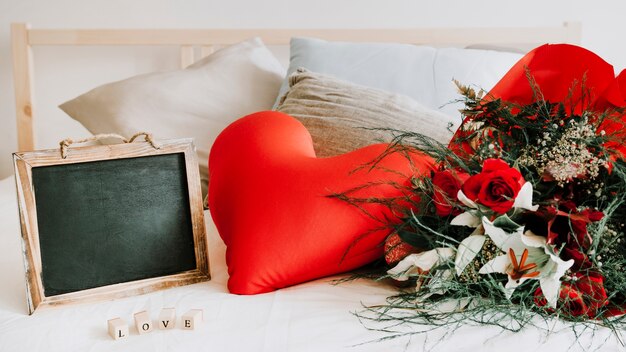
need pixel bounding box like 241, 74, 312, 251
59, 38, 285, 198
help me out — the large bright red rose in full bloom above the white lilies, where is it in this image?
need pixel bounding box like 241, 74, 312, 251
461, 159, 525, 214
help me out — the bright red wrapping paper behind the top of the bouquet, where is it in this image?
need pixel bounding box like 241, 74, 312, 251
450, 44, 626, 159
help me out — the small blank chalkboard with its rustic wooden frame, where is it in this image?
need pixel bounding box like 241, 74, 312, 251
13, 139, 210, 314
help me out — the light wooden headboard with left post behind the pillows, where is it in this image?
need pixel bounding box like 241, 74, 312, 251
11, 22, 581, 151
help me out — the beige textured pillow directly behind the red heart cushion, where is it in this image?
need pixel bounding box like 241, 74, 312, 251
276, 68, 461, 157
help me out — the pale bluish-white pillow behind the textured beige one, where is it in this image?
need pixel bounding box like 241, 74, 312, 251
274, 38, 522, 120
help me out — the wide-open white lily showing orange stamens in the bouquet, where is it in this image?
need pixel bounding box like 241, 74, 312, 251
479, 218, 574, 308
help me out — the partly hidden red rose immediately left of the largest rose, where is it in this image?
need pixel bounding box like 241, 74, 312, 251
433, 170, 469, 216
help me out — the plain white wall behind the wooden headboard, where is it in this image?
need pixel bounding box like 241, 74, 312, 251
0, 0, 626, 177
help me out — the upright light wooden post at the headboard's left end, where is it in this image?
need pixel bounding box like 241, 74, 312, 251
11, 23, 35, 151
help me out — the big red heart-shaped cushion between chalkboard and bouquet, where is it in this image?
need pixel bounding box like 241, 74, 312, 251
209, 111, 432, 294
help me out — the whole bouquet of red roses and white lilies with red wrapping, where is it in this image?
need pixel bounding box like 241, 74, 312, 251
336, 45, 626, 329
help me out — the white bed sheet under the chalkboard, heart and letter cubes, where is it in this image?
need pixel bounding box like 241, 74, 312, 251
0, 177, 625, 352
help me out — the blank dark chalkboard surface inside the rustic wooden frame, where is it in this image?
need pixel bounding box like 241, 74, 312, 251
32, 153, 196, 297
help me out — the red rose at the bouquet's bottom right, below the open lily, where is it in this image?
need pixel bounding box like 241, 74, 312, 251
535, 272, 609, 319
